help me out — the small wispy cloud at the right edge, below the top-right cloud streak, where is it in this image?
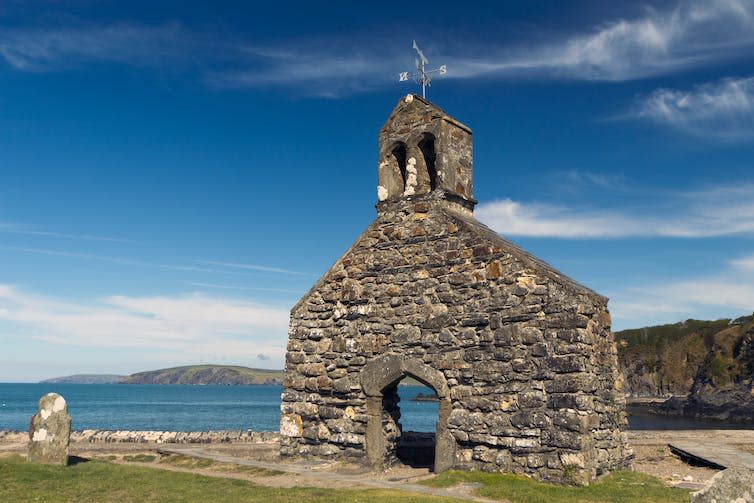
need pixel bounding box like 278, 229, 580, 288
631, 77, 754, 141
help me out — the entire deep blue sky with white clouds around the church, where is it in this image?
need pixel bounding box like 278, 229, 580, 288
0, 0, 754, 382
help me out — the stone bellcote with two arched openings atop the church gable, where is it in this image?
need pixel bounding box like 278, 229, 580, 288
377, 94, 476, 211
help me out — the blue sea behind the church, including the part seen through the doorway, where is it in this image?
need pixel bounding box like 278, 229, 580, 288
0, 383, 754, 431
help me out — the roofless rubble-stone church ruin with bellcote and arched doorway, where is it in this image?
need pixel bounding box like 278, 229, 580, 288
280, 95, 631, 483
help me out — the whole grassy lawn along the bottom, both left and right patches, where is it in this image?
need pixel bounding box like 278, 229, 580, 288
0, 455, 689, 503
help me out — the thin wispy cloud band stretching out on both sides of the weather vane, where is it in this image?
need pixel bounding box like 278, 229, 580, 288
209, 0, 754, 95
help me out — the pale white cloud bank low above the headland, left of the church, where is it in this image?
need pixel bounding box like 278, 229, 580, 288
0, 285, 288, 361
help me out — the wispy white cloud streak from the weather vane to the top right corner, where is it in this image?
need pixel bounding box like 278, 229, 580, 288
446, 0, 754, 81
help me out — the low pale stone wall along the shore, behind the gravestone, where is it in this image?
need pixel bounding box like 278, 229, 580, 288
0, 430, 280, 444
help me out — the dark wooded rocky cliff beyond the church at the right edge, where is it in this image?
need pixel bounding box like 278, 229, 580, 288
615, 315, 754, 420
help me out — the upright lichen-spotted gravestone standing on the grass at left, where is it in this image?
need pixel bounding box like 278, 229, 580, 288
28, 393, 71, 465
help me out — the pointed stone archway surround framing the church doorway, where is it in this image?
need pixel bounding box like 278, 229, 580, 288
361, 354, 456, 473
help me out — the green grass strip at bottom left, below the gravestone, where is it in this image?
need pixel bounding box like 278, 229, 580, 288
0, 456, 452, 503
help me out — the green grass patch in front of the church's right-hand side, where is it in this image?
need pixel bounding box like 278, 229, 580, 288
422, 471, 689, 503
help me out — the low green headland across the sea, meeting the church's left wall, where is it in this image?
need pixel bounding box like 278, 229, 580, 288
121, 365, 285, 385
